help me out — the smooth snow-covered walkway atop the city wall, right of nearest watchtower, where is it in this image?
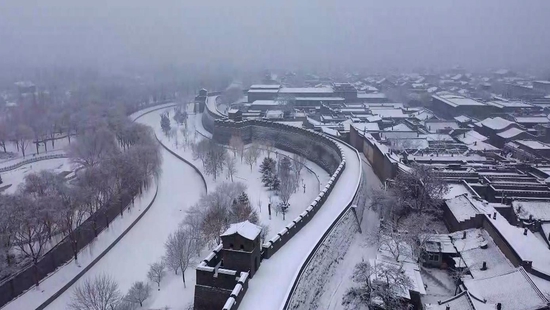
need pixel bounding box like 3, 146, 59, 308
239, 140, 361, 310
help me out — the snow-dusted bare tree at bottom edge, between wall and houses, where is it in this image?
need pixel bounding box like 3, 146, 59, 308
342, 262, 412, 310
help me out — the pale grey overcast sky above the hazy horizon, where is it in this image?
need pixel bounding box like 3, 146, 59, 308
0, 0, 550, 70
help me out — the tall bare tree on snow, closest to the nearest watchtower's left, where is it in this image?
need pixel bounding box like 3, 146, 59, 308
165, 228, 196, 287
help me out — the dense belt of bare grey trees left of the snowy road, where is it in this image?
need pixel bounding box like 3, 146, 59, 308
0, 108, 161, 284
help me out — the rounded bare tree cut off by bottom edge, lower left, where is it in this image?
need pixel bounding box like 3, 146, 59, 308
68, 275, 121, 310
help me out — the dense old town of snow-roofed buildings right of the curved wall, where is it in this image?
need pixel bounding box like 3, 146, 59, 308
212, 68, 550, 310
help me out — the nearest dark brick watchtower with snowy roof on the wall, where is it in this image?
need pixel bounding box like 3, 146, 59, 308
221, 221, 262, 278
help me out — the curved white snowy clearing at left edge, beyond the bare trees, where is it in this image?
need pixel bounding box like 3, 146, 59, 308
0, 158, 73, 194
